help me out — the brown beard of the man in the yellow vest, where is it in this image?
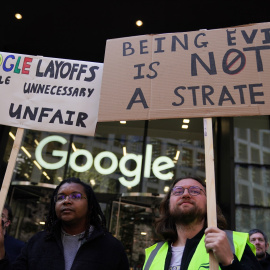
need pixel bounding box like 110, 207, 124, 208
170, 201, 206, 225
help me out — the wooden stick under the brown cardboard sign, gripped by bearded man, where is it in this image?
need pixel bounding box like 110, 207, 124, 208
203, 118, 219, 270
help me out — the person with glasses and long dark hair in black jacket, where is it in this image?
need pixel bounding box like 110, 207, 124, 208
0, 178, 129, 270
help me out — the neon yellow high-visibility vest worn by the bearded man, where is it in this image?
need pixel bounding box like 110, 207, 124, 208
143, 231, 255, 270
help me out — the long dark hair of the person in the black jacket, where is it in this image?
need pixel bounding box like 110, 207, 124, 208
45, 177, 106, 238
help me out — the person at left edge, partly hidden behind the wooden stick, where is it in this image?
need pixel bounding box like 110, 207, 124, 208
1, 204, 25, 262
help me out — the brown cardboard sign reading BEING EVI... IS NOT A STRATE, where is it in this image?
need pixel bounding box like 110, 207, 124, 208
98, 23, 270, 121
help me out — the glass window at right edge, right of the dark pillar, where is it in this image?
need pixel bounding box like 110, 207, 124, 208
234, 116, 270, 235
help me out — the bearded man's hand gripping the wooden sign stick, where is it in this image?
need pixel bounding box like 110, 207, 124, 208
204, 227, 234, 266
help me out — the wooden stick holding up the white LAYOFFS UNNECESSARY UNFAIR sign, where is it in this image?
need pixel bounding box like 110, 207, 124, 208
0, 128, 24, 213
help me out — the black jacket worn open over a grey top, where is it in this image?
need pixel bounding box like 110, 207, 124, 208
0, 229, 129, 270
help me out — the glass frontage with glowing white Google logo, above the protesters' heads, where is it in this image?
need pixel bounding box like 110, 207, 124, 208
5, 119, 205, 194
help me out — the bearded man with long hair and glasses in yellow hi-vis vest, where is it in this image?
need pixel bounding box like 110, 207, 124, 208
143, 177, 261, 270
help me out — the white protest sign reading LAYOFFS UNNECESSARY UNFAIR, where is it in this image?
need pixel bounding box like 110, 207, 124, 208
0, 52, 103, 136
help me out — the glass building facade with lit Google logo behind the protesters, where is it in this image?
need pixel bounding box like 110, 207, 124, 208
0, 116, 270, 269
